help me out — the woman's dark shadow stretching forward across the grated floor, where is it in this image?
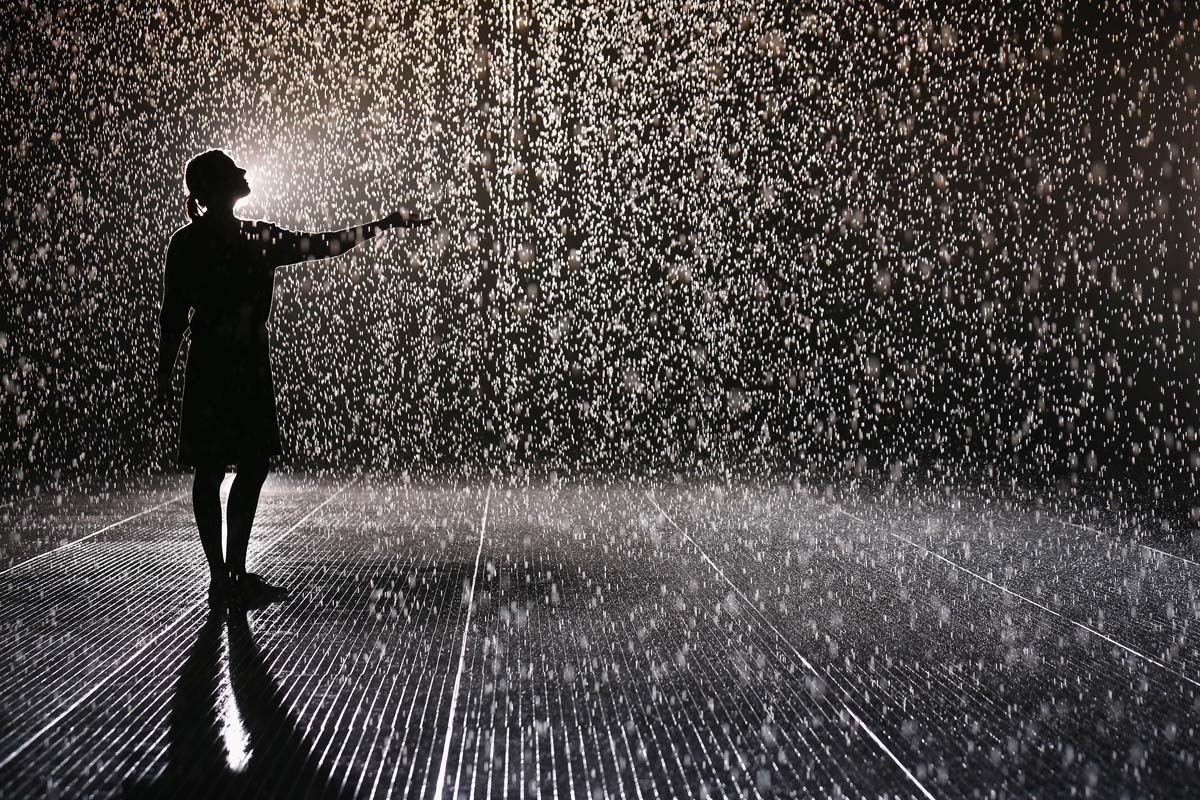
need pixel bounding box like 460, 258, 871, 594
124, 609, 354, 800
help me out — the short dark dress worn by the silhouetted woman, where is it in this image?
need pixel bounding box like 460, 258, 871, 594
162, 217, 304, 467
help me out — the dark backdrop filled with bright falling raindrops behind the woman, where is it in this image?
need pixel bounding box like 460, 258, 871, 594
0, 0, 1200, 519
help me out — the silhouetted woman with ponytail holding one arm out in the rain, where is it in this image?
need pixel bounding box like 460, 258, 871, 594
157, 150, 432, 604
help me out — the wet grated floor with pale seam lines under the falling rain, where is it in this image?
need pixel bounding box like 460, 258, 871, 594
0, 475, 1200, 799
